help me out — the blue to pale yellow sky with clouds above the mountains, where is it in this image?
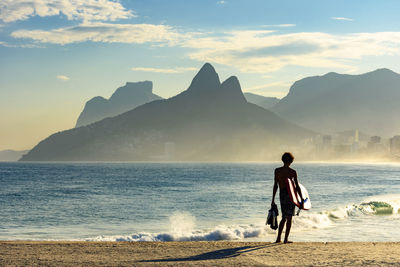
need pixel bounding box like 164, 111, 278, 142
0, 0, 400, 150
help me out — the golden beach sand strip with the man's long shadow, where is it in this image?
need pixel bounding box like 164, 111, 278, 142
0, 241, 400, 266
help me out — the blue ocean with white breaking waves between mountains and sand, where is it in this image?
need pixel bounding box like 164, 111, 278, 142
0, 162, 400, 242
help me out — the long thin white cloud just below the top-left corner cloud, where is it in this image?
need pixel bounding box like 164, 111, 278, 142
11, 22, 185, 45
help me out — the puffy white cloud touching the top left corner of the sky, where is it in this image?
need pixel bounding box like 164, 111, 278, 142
0, 0, 134, 22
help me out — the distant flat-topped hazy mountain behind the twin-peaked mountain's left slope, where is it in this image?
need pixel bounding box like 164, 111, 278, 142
75, 81, 162, 127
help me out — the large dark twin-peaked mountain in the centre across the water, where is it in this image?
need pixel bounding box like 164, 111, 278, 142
22, 63, 312, 161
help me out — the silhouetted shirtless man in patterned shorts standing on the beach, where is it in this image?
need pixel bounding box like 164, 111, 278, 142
272, 152, 304, 244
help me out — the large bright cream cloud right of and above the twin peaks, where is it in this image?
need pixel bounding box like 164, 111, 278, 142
183, 30, 400, 73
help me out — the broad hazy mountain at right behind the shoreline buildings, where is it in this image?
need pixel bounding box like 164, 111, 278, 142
271, 69, 400, 136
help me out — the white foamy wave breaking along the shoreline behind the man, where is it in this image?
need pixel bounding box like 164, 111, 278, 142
85, 195, 400, 242
